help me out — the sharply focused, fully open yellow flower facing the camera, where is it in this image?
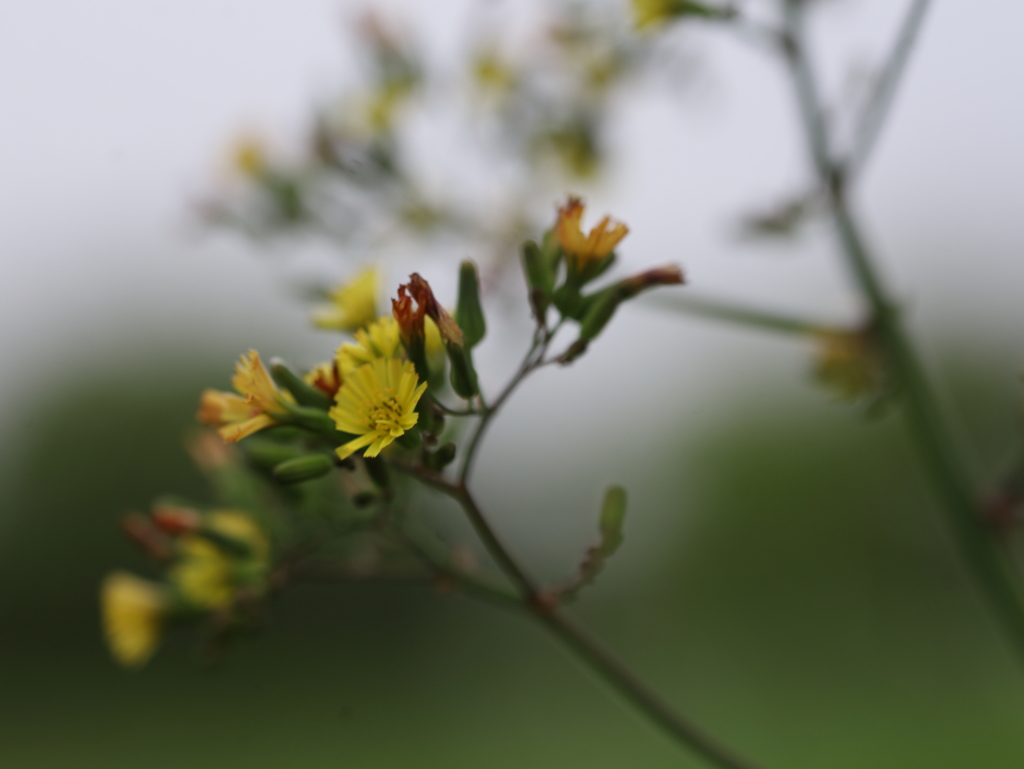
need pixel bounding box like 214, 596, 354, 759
331, 357, 427, 459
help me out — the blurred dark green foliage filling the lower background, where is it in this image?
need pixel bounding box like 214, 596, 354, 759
0, 348, 1024, 769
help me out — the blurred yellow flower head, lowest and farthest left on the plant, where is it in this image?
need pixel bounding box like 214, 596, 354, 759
99, 571, 168, 668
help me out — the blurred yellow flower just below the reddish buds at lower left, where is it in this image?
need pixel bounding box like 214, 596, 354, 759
170, 510, 270, 609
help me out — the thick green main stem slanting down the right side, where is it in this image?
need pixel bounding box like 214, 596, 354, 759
784, 0, 1024, 656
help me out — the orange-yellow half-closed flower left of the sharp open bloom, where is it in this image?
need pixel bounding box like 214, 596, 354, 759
196, 350, 295, 442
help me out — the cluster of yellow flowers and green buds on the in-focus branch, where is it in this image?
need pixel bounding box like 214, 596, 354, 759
101, 198, 682, 668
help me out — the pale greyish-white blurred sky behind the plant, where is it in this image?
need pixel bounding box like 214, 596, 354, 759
0, 0, 1024, 514
